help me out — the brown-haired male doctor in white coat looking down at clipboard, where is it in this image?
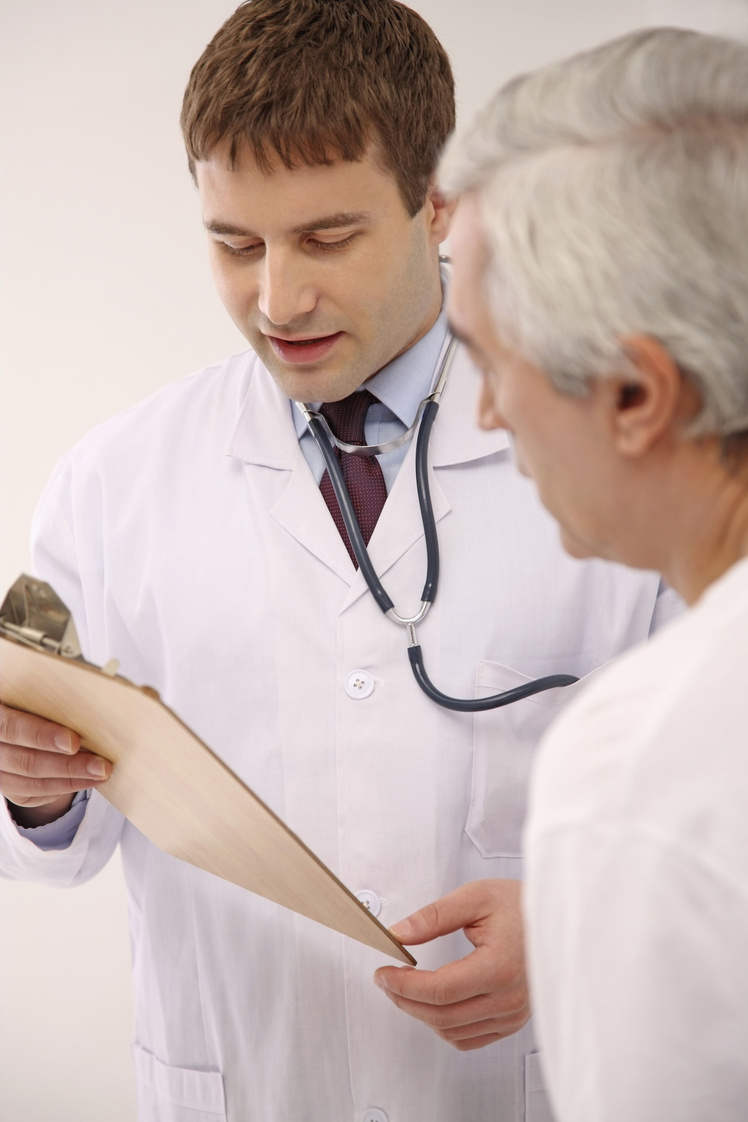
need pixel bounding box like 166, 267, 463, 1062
0, 0, 677, 1122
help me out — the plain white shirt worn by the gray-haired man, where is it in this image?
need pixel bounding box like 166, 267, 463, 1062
525, 558, 748, 1122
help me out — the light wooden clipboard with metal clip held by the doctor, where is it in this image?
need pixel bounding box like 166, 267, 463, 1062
0, 577, 415, 964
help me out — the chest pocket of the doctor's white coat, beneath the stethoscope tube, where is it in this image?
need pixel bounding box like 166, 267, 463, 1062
465, 662, 589, 857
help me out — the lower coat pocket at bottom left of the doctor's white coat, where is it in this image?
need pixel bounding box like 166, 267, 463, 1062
132, 1045, 227, 1122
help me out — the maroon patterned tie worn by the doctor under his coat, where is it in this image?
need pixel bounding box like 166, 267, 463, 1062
320, 389, 387, 569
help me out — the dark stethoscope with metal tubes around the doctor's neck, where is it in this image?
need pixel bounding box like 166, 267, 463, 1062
296, 332, 578, 712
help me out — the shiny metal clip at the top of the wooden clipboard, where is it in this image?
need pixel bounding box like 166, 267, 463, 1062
0, 573, 83, 659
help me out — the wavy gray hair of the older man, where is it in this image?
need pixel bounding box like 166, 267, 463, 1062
440, 28, 748, 435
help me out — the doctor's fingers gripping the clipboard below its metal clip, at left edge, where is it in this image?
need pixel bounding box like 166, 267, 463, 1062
0, 706, 112, 807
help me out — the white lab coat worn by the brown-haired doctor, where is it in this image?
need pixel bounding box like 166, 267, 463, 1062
2, 343, 677, 1122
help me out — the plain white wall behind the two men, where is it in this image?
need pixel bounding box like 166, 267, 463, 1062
0, 0, 748, 1122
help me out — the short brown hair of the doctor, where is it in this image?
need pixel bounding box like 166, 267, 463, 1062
181, 0, 454, 215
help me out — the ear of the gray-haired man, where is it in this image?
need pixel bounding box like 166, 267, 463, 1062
601, 335, 700, 459
